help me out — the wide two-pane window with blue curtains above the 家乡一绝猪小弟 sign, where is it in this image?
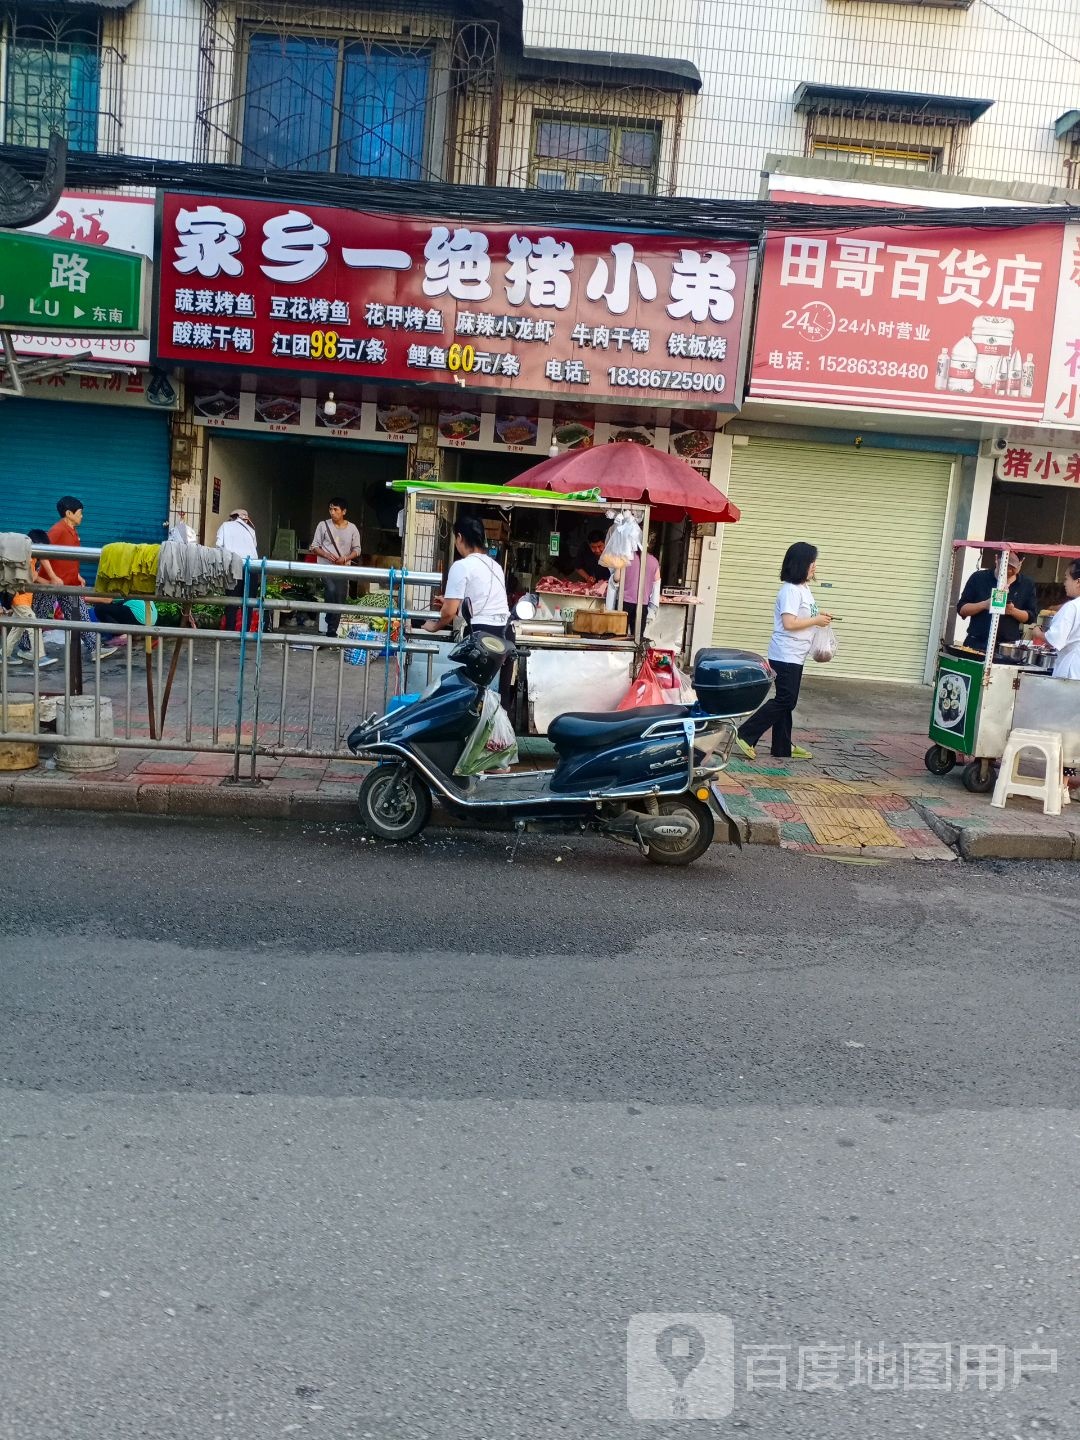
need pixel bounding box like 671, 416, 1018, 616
240, 33, 432, 180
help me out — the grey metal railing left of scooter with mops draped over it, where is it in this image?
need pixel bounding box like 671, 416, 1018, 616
0, 546, 442, 783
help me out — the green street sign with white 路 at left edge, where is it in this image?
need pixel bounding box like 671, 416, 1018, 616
0, 230, 150, 337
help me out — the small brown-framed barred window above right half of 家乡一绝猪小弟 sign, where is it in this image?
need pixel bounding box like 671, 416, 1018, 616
528, 115, 660, 194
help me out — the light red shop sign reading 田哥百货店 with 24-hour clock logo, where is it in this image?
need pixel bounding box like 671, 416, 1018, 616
749, 225, 1063, 423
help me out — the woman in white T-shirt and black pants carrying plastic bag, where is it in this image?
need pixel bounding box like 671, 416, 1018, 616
736, 540, 832, 760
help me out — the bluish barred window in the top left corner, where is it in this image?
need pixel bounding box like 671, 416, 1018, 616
3, 12, 101, 151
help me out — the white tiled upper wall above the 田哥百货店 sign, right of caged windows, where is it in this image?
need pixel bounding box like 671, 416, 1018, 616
524, 0, 1080, 197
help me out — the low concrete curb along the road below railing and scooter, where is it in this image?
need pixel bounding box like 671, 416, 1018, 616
0, 775, 780, 848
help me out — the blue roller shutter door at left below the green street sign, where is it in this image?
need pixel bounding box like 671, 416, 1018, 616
0, 400, 168, 546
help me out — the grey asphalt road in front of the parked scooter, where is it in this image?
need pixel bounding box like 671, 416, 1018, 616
0, 812, 1080, 1440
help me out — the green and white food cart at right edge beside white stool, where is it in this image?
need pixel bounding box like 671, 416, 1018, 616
924, 540, 1080, 793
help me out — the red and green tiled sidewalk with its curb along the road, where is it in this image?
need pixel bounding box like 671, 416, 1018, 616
0, 674, 1080, 863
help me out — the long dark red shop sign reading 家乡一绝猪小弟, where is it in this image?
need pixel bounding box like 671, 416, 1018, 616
154, 194, 749, 410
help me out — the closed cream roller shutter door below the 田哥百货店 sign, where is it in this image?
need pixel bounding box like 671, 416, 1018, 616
713, 436, 952, 681
